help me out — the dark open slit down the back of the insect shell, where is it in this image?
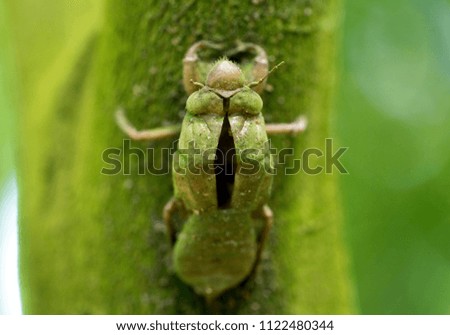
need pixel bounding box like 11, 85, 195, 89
214, 99, 236, 209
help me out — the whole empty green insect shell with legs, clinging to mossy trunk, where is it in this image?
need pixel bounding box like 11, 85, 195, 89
116, 41, 306, 299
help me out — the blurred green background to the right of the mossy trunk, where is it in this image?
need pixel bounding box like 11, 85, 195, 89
338, 0, 450, 314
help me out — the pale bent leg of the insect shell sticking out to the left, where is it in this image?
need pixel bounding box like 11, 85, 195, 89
116, 108, 181, 141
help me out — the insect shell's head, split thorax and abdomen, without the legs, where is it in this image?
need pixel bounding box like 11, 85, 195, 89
173, 59, 273, 296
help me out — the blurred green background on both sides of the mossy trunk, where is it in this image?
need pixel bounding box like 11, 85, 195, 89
0, 0, 450, 314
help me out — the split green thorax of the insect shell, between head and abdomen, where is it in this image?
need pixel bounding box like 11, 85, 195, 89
173, 60, 272, 212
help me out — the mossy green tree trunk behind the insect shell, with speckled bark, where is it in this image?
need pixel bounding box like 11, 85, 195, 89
16, 0, 353, 314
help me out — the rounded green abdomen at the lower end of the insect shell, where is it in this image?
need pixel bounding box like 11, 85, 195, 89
174, 209, 257, 298
